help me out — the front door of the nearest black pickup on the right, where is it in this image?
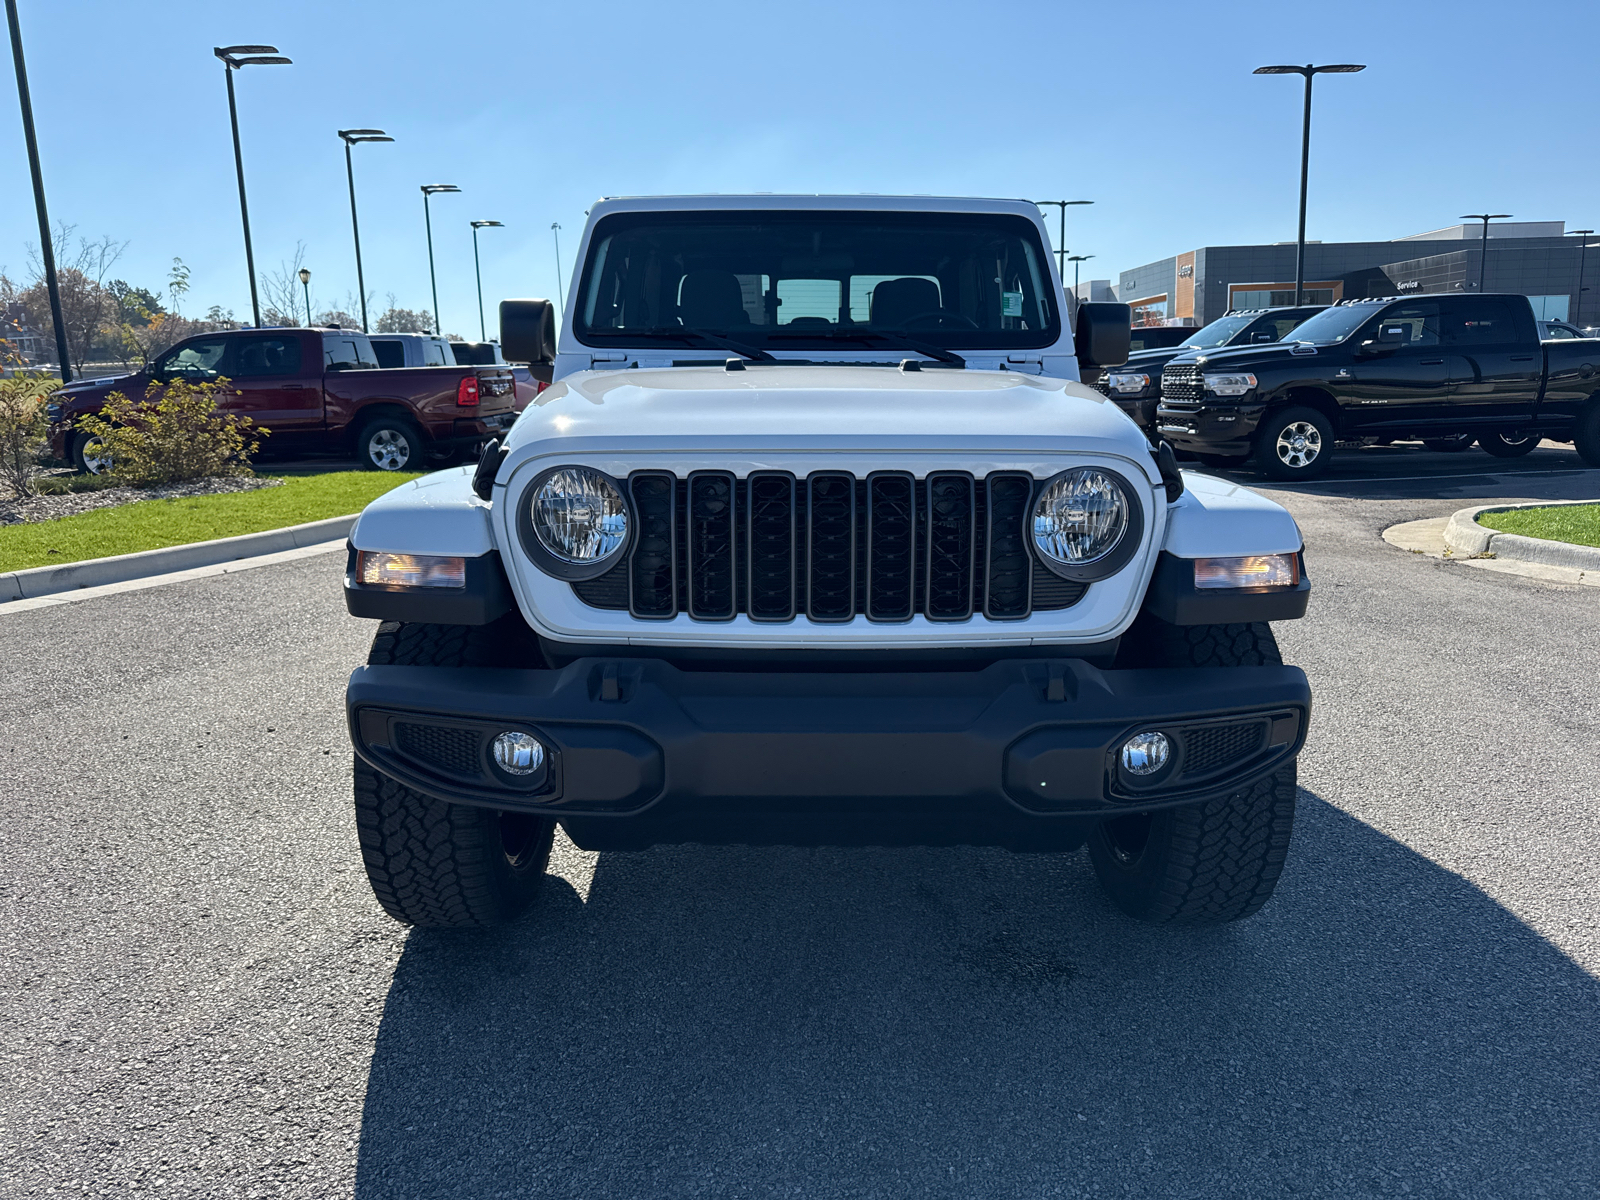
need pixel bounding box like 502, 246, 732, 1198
1333, 299, 1451, 434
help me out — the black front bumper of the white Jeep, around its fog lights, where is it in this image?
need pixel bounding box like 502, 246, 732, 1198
347, 658, 1310, 850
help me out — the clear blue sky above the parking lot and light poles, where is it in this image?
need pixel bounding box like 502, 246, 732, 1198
0, 0, 1600, 336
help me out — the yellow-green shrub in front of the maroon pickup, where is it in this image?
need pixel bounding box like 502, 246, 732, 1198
78, 378, 270, 488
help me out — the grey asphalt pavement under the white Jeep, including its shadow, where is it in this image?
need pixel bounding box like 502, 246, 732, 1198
0, 448, 1600, 1200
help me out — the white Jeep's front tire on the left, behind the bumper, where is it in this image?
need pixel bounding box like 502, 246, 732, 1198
355, 614, 555, 928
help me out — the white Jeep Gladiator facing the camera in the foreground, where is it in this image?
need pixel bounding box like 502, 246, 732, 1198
346, 195, 1310, 926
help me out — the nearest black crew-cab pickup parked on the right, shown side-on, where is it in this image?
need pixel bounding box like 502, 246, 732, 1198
1155, 294, 1600, 480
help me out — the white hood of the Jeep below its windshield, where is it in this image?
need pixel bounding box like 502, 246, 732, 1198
507, 363, 1149, 459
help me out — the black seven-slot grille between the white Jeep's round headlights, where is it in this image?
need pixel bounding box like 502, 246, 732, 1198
571, 470, 1088, 622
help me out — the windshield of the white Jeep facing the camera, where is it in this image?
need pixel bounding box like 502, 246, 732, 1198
573, 211, 1061, 357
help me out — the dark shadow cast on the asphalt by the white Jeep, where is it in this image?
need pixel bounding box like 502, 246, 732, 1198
355, 792, 1600, 1200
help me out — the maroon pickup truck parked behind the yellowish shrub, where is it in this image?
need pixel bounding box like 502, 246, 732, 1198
50, 330, 517, 470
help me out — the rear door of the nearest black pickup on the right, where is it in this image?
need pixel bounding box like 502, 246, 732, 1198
1440, 296, 1544, 432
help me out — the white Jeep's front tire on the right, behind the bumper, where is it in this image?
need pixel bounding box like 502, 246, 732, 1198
1088, 618, 1294, 925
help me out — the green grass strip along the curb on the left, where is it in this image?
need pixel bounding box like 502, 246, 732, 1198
0, 470, 422, 571
